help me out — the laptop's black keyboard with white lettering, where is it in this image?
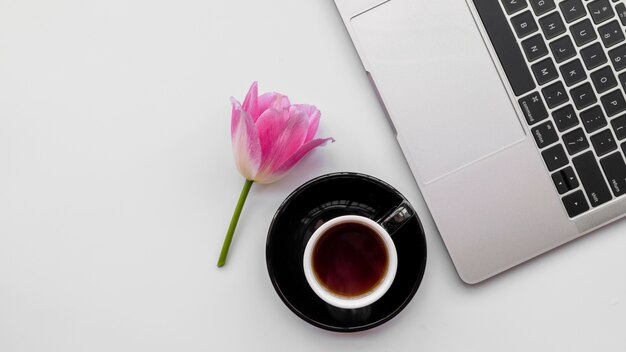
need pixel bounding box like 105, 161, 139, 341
474, 0, 626, 218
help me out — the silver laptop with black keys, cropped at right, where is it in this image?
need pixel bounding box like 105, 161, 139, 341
334, 0, 626, 284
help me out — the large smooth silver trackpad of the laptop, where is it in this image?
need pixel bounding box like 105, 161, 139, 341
351, 0, 526, 183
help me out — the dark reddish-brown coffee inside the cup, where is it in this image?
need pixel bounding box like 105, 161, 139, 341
312, 222, 389, 298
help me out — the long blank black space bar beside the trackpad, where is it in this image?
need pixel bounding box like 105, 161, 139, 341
474, 0, 535, 96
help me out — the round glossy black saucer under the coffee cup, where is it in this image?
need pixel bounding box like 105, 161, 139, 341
265, 173, 426, 332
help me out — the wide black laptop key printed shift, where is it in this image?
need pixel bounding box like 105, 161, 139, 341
572, 151, 612, 208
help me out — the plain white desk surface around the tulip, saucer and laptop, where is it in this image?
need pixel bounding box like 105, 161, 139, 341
0, 0, 626, 352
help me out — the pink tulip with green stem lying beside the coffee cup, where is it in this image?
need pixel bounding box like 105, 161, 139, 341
217, 82, 334, 267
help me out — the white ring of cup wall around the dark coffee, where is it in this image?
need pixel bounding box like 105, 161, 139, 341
303, 215, 398, 309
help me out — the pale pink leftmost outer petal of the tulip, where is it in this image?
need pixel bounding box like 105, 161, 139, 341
231, 99, 261, 180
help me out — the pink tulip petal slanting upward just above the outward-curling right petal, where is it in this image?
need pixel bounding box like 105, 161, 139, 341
259, 109, 309, 179
